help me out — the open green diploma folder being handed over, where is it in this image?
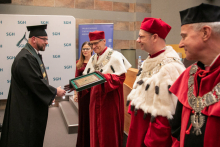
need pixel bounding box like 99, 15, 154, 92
69, 72, 106, 91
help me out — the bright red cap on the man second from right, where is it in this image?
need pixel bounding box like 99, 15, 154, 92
140, 17, 171, 39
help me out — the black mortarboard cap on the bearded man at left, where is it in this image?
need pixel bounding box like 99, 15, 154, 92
27, 25, 47, 38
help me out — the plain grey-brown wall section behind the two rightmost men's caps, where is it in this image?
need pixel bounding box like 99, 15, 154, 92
151, 0, 220, 44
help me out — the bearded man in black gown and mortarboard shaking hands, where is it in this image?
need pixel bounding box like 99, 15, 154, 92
0, 25, 65, 147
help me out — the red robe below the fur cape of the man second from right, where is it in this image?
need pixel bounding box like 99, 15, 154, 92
126, 50, 172, 147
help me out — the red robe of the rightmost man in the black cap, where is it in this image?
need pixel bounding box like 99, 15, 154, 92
170, 57, 220, 147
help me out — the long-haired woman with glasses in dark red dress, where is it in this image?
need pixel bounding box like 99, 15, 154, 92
74, 42, 93, 147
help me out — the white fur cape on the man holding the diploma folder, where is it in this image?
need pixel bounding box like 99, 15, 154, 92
83, 48, 131, 76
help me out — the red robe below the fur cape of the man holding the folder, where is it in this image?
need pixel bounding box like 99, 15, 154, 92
89, 74, 125, 147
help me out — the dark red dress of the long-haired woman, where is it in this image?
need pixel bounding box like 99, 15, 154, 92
75, 61, 90, 147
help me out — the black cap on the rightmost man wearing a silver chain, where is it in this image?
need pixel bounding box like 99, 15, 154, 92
180, 3, 220, 26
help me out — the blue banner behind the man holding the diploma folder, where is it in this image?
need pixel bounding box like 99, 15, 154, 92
78, 23, 114, 59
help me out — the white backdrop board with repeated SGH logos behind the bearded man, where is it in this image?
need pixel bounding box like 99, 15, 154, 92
0, 14, 76, 99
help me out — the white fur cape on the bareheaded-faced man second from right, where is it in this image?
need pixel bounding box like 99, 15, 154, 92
127, 46, 185, 119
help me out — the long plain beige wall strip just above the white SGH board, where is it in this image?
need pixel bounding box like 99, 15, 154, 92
0, 3, 136, 21
